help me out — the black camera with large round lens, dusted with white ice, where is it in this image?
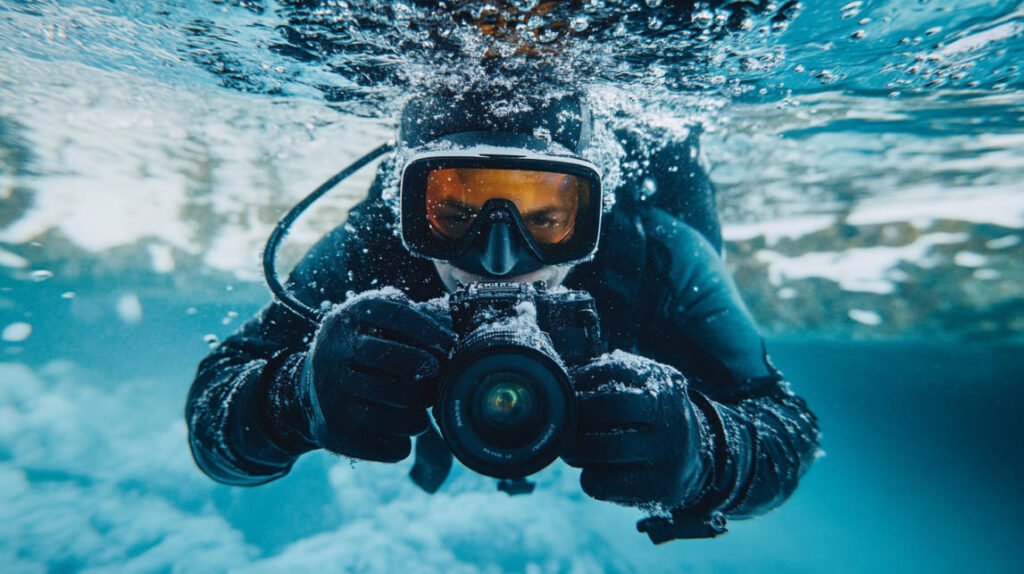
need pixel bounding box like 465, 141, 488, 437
433, 281, 604, 479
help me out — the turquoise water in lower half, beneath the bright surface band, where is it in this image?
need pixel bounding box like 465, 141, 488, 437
0, 294, 1024, 572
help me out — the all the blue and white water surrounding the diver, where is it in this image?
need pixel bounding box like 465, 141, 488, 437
0, 0, 1024, 574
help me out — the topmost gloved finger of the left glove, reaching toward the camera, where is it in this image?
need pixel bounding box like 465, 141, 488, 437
350, 299, 456, 355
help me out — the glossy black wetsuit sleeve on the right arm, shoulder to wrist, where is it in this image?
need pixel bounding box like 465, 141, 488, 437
640, 210, 818, 518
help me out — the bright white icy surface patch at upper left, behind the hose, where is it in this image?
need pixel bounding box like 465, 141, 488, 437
0, 57, 393, 280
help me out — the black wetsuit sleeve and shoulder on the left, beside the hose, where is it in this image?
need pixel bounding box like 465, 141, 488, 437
185, 171, 443, 485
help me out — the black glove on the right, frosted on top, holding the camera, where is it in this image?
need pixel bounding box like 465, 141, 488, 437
562, 351, 708, 509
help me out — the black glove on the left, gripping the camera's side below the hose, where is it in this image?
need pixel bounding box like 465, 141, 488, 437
301, 290, 455, 462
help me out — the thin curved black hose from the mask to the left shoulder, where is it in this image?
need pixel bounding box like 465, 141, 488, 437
263, 141, 394, 325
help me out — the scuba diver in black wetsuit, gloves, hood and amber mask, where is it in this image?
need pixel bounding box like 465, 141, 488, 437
185, 83, 818, 542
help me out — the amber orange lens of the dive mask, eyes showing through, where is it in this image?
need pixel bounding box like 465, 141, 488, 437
426, 168, 590, 245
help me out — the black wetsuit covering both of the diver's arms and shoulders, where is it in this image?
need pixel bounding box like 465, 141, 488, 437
185, 154, 818, 517
